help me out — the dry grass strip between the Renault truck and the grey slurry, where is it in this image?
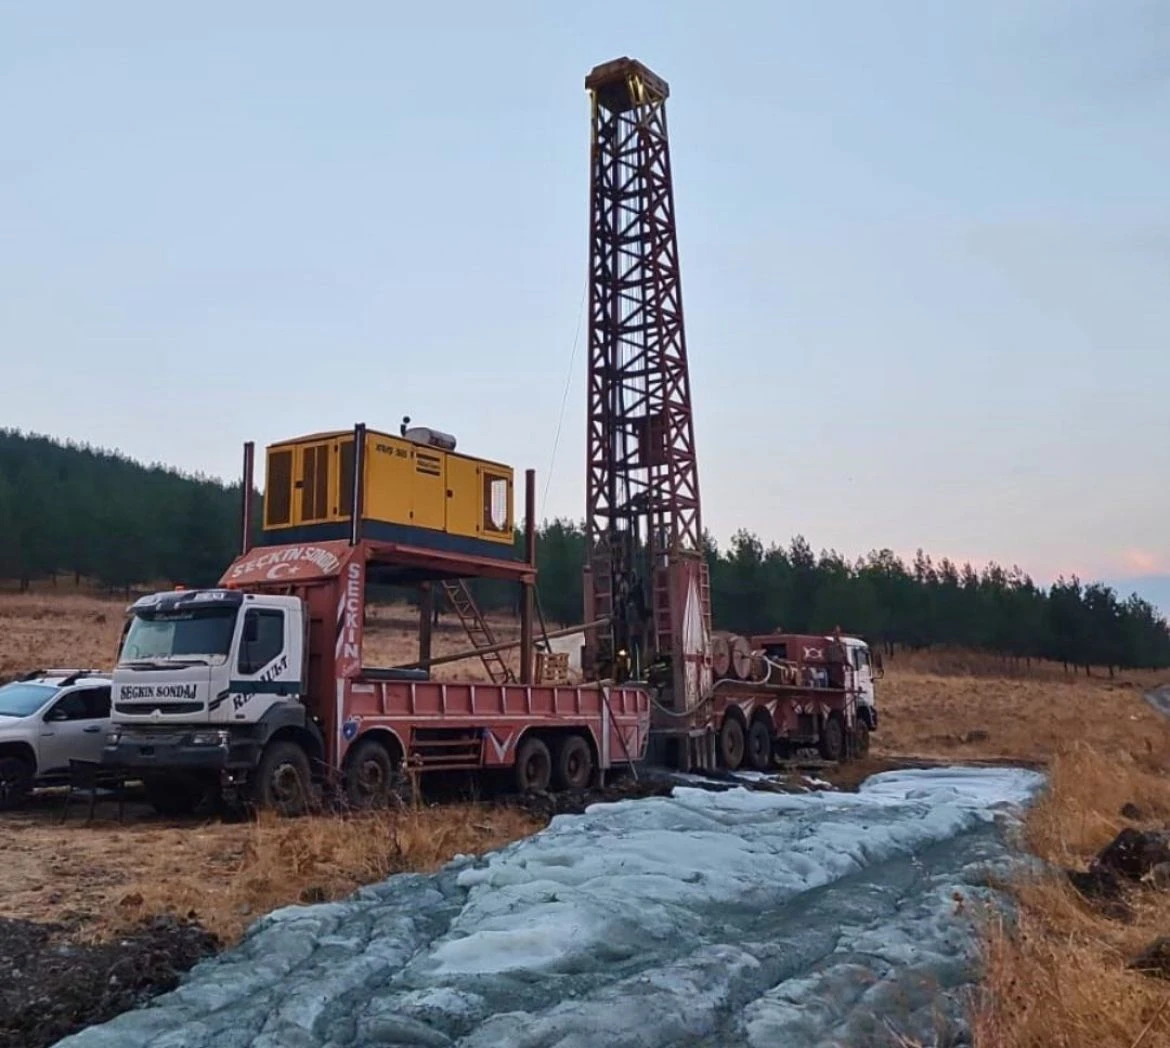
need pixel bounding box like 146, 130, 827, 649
0, 801, 541, 943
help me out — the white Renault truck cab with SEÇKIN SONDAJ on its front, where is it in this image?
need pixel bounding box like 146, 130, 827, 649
103, 588, 321, 814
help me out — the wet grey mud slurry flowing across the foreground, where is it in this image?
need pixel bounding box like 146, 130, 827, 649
54, 768, 1042, 1048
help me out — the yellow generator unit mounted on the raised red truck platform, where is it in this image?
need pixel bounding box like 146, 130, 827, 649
262, 419, 515, 559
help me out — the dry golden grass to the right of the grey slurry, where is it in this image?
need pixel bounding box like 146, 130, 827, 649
874, 653, 1170, 1048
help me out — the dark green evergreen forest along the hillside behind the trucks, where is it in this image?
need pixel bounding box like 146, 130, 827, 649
0, 430, 1170, 670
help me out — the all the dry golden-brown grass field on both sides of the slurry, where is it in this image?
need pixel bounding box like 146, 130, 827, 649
0, 594, 1170, 1048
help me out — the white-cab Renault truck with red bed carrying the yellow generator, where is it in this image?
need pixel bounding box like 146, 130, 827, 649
104, 426, 649, 814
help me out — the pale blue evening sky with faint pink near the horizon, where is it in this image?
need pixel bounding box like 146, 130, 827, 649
0, 0, 1170, 611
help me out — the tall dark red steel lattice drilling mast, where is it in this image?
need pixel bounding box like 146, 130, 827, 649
585, 58, 710, 670
